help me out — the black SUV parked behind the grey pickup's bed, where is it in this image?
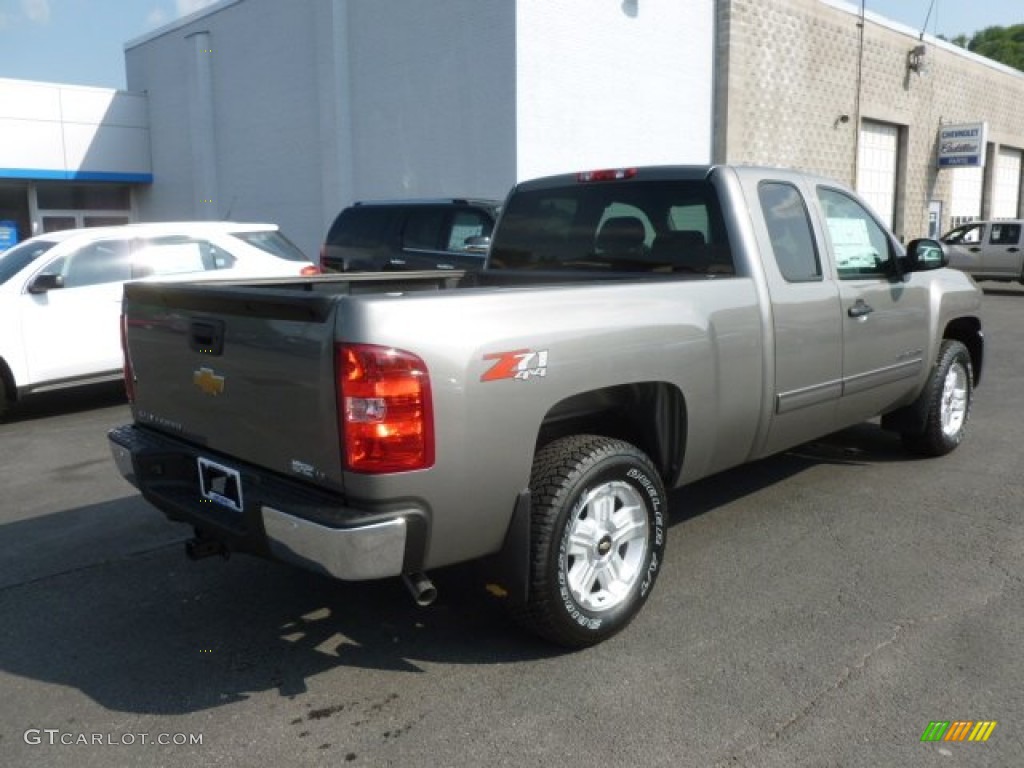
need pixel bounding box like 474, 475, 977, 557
321, 199, 500, 271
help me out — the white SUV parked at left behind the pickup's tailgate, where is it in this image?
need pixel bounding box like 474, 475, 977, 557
0, 221, 319, 414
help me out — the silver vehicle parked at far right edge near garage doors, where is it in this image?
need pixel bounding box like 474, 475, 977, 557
942, 219, 1024, 283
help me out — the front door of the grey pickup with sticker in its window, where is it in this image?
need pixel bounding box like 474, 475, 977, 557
817, 186, 929, 426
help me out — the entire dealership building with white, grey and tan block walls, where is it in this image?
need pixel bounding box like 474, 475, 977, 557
0, 0, 1024, 254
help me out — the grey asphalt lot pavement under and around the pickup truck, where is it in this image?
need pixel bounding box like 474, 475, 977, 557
0, 284, 1024, 768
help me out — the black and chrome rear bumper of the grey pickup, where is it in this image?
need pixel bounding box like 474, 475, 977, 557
108, 425, 427, 581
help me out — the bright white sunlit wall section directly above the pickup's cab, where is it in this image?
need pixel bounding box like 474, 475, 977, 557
516, 0, 715, 179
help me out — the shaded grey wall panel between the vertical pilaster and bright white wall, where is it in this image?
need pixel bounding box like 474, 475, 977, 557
347, 0, 516, 204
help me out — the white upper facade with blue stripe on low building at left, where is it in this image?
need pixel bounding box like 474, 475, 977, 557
0, 79, 151, 181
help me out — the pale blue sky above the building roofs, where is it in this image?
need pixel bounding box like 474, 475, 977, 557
0, 0, 1024, 88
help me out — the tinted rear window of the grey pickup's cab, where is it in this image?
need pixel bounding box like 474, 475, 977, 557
489, 179, 735, 274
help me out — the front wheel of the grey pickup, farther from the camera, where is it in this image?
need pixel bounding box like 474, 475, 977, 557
903, 339, 974, 456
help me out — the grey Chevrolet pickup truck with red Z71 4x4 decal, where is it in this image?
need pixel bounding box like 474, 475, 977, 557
110, 166, 983, 647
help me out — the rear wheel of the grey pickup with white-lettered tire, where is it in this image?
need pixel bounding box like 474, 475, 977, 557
517, 435, 668, 648
